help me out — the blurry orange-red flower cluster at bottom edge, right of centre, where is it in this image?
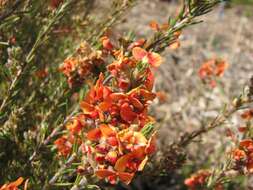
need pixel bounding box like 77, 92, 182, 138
184, 170, 211, 190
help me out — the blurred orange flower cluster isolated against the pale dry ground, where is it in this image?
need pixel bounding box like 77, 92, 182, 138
198, 59, 228, 88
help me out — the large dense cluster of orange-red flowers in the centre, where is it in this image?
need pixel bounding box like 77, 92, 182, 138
55, 37, 162, 184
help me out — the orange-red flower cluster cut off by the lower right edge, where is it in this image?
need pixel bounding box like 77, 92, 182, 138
232, 139, 253, 173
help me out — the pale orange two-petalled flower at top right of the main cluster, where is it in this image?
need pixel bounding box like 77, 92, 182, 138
132, 47, 162, 67
